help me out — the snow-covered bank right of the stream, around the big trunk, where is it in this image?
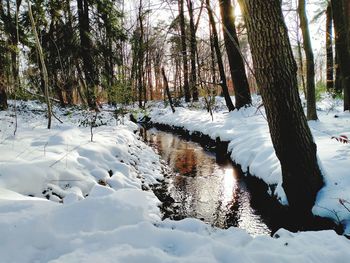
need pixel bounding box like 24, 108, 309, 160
150, 97, 350, 234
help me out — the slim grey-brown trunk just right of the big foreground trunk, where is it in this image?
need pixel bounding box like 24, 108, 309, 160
298, 0, 317, 120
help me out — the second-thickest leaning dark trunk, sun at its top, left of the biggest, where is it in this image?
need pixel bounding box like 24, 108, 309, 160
220, 0, 252, 109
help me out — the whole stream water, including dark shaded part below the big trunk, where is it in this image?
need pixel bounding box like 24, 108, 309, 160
140, 128, 340, 236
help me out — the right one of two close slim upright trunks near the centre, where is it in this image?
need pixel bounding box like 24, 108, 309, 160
187, 0, 199, 101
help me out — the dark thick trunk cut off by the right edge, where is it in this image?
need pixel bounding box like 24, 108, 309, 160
331, 0, 350, 110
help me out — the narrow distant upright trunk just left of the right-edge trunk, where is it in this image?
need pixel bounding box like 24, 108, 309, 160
326, 3, 334, 93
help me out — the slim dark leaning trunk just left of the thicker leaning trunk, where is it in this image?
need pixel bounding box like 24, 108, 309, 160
206, 0, 235, 111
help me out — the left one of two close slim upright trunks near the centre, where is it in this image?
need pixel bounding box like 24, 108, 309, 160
178, 0, 191, 102
